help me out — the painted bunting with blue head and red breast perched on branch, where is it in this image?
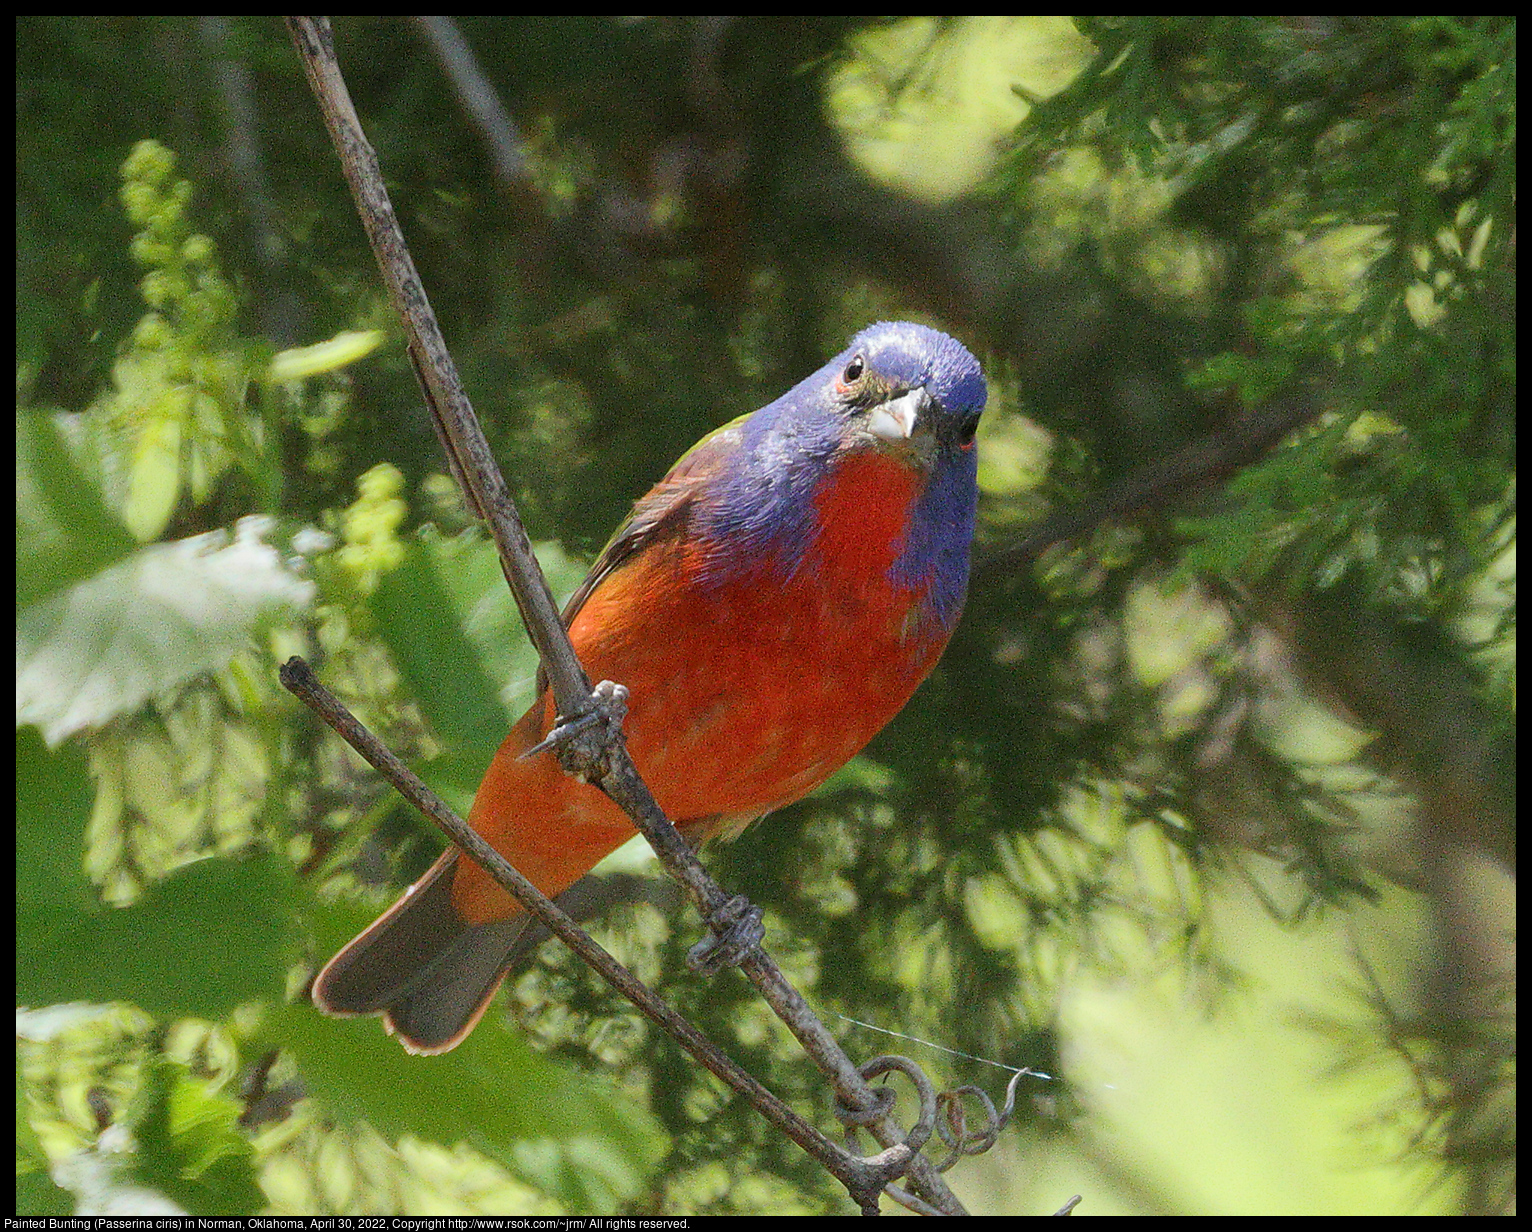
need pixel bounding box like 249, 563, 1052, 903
313, 322, 988, 1054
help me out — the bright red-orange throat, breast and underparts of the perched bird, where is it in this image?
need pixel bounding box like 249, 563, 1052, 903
453, 454, 947, 922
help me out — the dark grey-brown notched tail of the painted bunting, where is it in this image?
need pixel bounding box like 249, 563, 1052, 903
314, 847, 529, 1054
